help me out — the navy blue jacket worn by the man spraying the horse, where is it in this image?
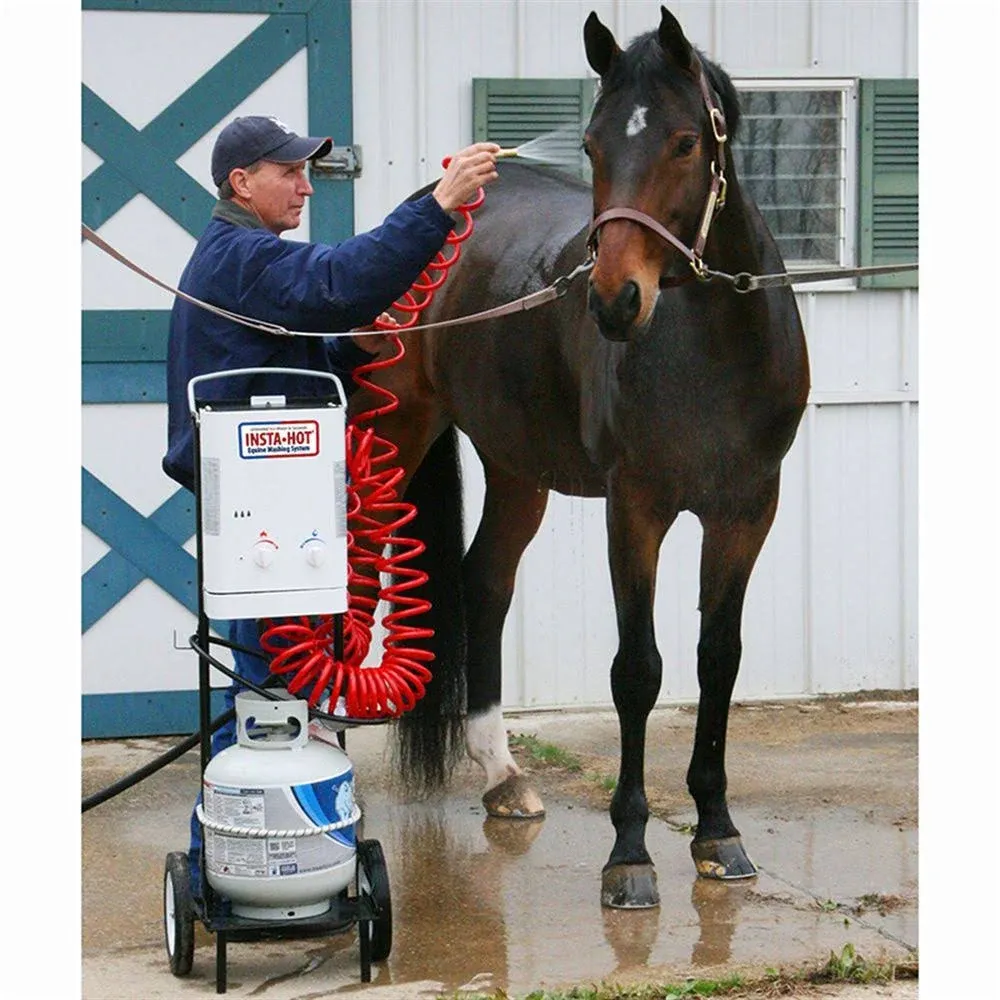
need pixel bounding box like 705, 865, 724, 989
163, 194, 454, 491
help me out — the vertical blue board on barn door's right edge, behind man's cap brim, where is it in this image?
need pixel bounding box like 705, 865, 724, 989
307, 0, 354, 243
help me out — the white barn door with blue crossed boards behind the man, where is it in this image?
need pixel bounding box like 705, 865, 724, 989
81, 0, 354, 737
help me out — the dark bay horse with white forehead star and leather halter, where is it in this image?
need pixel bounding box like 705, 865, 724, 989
351, 7, 809, 908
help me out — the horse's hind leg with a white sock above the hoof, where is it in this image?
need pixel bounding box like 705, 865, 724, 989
462, 466, 548, 819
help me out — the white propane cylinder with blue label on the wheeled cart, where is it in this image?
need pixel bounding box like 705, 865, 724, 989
201, 691, 360, 920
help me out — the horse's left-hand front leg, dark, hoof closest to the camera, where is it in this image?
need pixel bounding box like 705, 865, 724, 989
601, 481, 676, 908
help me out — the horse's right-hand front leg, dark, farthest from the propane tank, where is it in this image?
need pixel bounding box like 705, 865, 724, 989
687, 479, 778, 879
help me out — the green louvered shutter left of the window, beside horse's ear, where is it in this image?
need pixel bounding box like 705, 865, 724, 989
472, 78, 594, 180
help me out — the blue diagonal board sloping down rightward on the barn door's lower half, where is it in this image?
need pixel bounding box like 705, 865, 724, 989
81, 469, 198, 609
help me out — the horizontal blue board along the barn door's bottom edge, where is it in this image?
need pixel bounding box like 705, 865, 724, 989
81, 688, 226, 740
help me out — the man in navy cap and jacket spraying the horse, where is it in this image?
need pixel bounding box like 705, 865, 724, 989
163, 116, 500, 894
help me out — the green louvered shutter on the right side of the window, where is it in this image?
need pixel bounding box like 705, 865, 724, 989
858, 79, 918, 288
